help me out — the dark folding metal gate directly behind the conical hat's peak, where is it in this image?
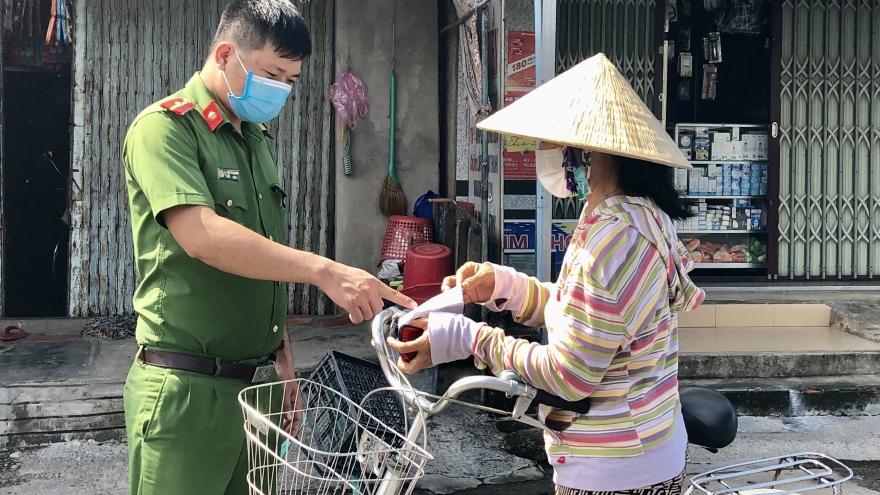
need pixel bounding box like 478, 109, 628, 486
553, 0, 665, 219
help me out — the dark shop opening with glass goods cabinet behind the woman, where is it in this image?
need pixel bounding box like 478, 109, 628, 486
666, 0, 779, 282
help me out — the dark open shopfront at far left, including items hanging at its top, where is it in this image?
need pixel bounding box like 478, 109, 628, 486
0, 0, 72, 317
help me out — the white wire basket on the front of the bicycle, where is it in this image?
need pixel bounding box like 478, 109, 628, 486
238, 379, 432, 495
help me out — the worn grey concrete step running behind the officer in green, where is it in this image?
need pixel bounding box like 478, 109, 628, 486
0, 319, 377, 451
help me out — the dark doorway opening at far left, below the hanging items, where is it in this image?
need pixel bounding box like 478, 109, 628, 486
2, 57, 71, 318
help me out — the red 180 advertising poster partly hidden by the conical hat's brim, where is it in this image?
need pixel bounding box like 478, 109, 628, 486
504, 31, 536, 180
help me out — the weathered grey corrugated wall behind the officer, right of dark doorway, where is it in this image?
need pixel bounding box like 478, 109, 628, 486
69, 0, 335, 316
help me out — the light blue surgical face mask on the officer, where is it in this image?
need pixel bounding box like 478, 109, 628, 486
223, 50, 292, 124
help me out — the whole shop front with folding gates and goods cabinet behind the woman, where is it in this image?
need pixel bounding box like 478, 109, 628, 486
496, 0, 880, 283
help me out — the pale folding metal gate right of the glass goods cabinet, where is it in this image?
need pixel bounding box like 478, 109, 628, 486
776, 0, 880, 279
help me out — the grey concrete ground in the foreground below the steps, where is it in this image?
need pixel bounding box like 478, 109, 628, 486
0, 415, 880, 495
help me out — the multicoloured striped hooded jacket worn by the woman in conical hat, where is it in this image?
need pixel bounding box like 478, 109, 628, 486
472, 196, 705, 464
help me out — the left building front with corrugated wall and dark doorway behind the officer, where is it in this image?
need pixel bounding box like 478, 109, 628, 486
0, 0, 336, 318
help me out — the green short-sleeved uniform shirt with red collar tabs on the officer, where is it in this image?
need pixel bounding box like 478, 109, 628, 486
123, 73, 287, 361
